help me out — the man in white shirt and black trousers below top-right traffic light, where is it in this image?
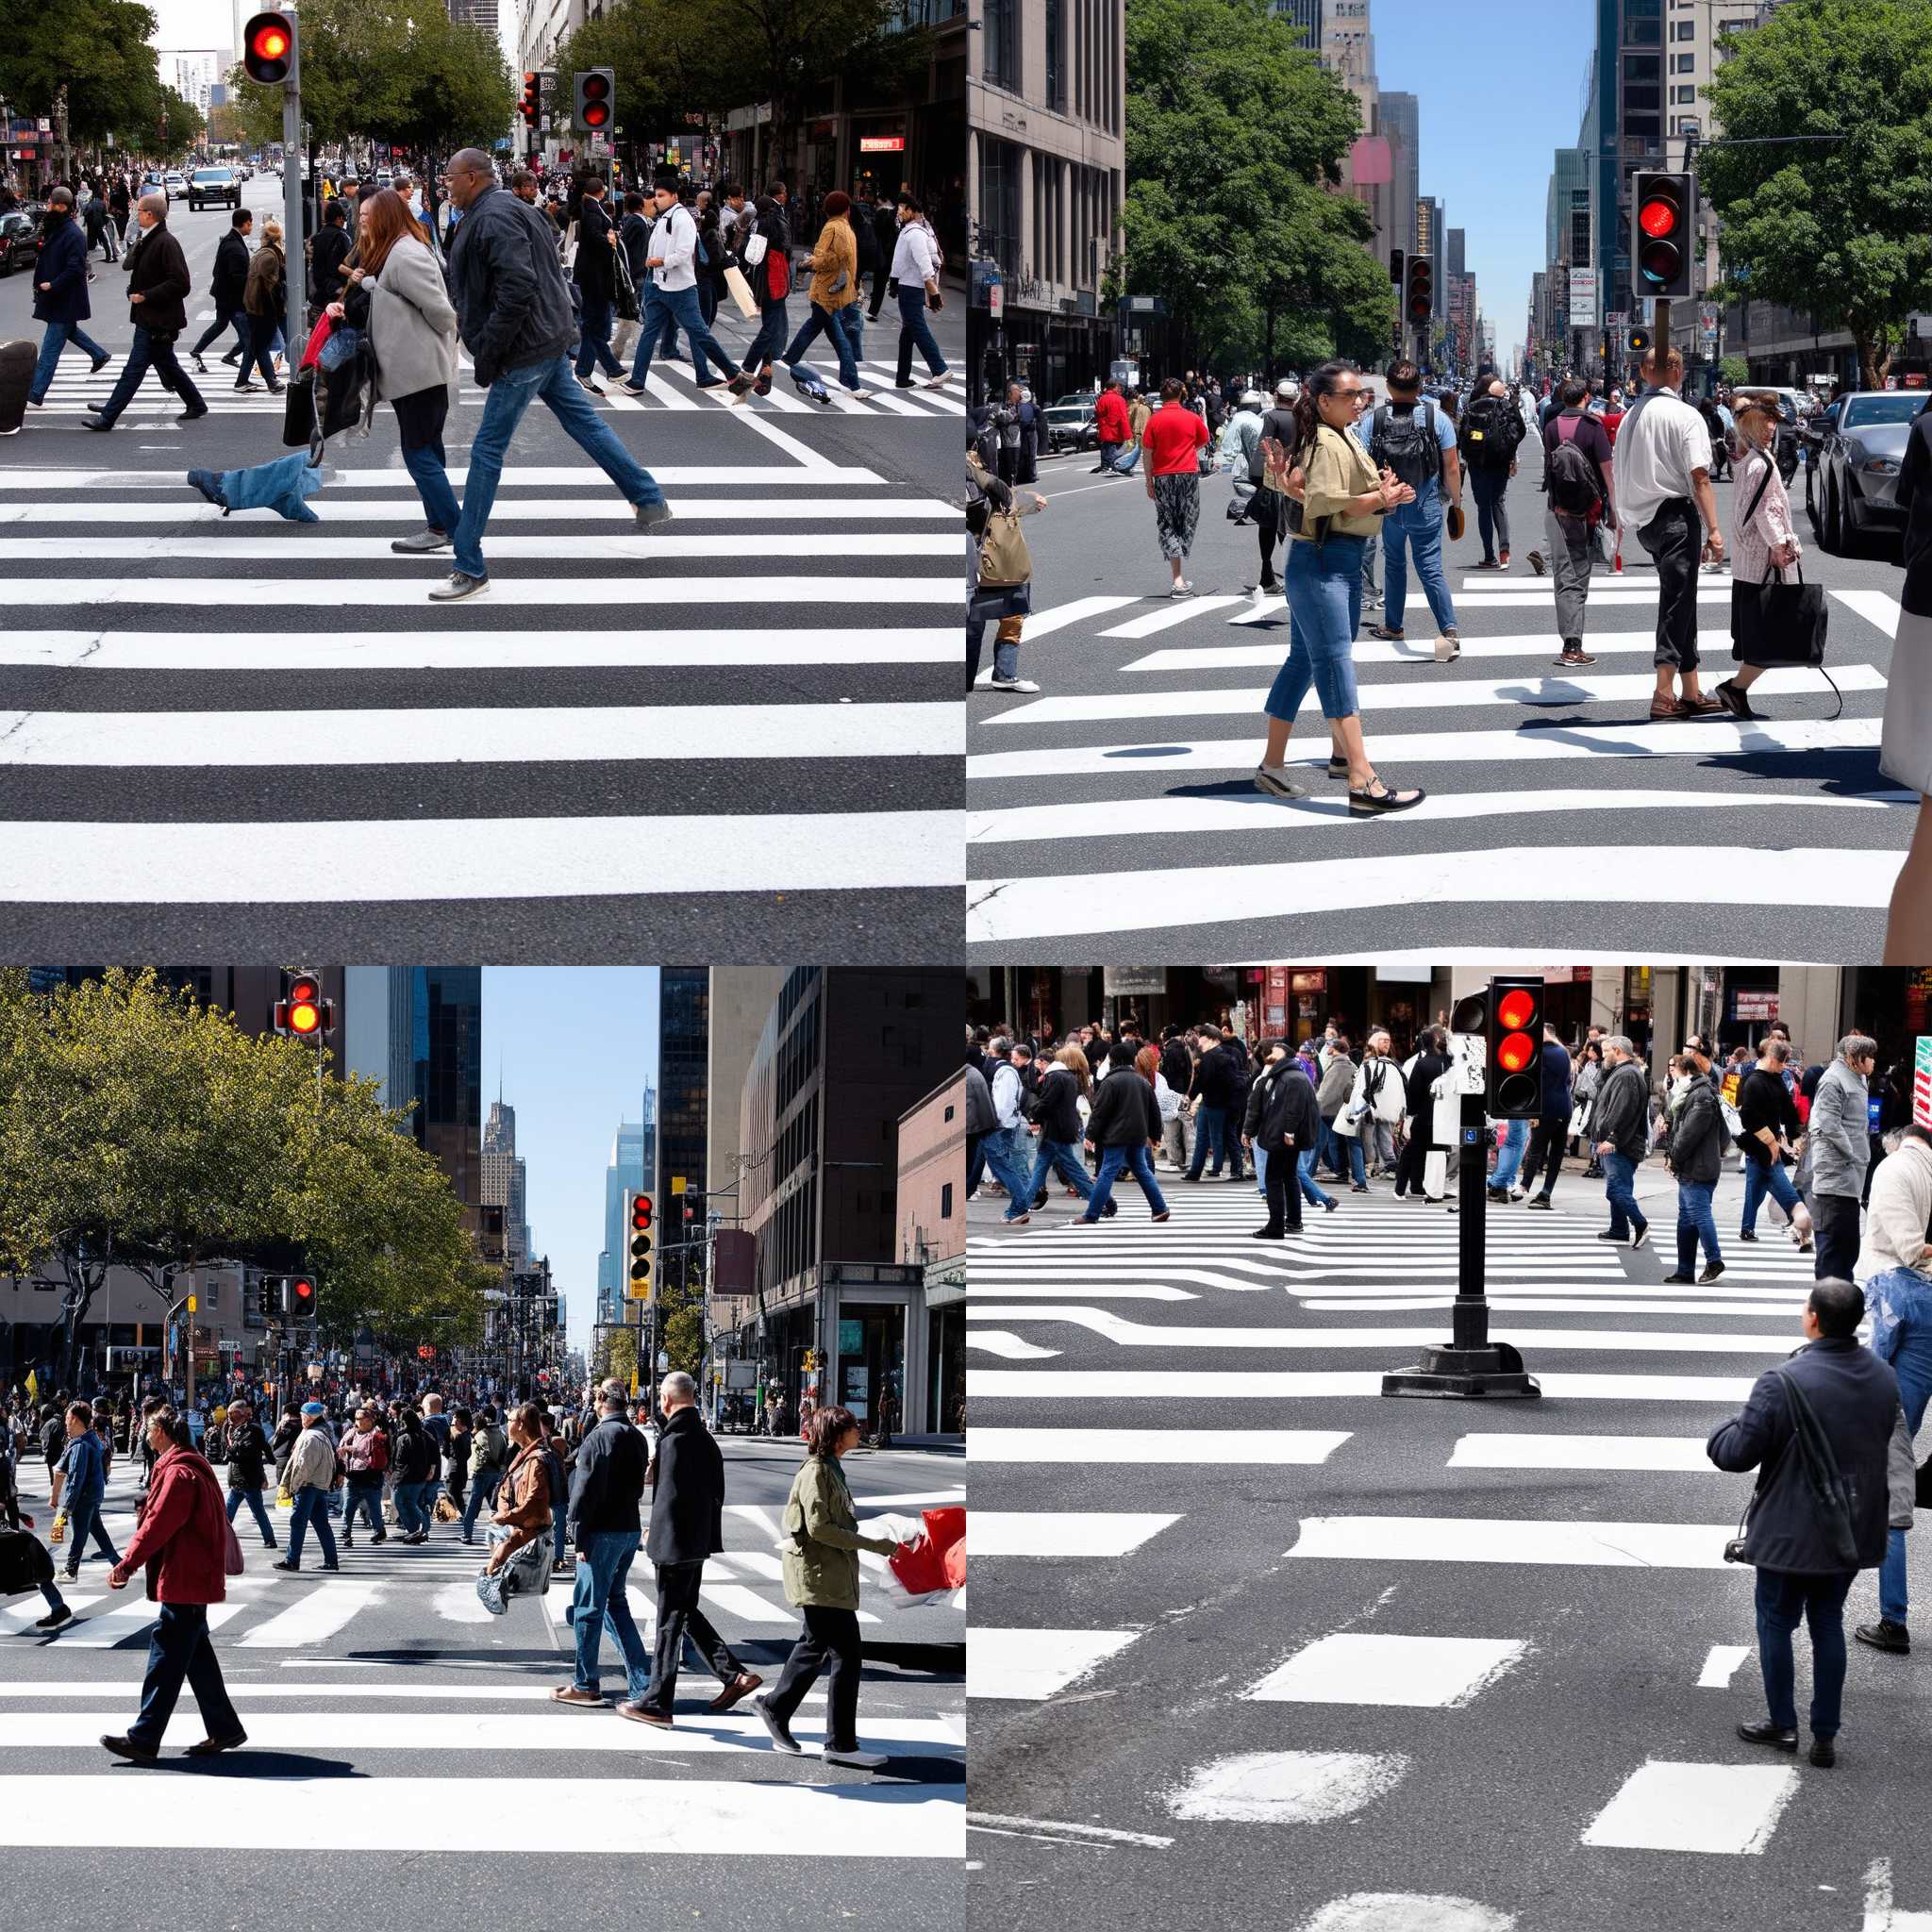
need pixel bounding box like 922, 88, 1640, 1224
1615, 350, 1724, 719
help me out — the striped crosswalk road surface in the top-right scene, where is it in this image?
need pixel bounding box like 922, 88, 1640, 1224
968, 415, 1917, 964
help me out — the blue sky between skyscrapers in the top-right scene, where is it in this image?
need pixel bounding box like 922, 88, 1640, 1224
1370, 0, 1596, 359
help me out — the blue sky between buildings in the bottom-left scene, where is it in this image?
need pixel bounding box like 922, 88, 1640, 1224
483, 966, 657, 1353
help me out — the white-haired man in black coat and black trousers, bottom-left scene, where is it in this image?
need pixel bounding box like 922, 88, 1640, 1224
618, 1370, 765, 1731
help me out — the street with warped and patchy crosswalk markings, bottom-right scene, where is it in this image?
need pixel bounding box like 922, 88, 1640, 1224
968, 1161, 1932, 1932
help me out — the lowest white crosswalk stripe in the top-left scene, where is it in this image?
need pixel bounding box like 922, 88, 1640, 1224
0, 811, 960, 907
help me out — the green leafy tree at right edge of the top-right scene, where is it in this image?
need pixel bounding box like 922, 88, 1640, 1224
1698, 0, 1932, 389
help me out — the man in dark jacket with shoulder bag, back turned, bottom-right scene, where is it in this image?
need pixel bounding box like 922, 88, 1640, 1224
1706, 1281, 1913, 1766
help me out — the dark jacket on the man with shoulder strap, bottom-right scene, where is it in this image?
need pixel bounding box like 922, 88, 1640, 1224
1706, 1335, 1899, 1576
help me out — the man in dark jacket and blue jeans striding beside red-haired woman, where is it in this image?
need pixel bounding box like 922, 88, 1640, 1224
429, 147, 671, 603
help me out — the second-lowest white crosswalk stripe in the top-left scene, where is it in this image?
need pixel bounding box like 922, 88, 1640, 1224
0, 703, 958, 769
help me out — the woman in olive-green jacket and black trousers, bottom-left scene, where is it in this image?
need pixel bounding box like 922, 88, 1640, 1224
752, 1408, 898, 1772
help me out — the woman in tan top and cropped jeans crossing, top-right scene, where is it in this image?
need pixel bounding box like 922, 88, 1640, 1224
1254, 361, 1424, 817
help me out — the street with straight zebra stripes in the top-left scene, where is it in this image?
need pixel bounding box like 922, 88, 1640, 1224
0, 175, 964, 962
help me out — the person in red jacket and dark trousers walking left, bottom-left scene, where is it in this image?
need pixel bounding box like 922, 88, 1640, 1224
100, 1403, 247, 1764
